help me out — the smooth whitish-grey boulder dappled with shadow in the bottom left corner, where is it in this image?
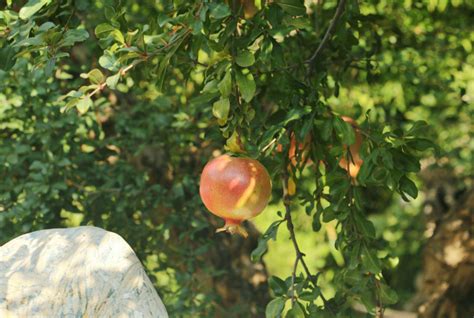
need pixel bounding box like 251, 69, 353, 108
0, 226, 168, 318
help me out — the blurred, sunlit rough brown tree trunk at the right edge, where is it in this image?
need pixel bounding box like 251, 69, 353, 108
415, 171, 474, 318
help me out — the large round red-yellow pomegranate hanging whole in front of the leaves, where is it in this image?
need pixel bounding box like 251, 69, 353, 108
199, 155, 272, 237
